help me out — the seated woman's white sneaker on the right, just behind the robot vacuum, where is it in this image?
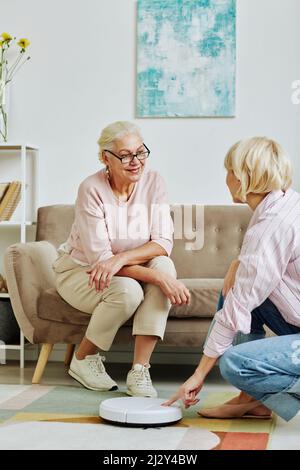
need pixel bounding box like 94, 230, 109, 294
126, 364, 157, 398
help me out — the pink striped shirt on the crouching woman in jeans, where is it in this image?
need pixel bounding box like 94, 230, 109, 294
204, 189, 300, 358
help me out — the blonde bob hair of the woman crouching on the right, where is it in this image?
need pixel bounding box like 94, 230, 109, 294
224, 137, 292, 202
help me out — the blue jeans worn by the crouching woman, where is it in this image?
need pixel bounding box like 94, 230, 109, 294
212, 296, 300, 421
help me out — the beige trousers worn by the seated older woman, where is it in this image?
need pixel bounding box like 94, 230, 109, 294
52, 253, 176, 351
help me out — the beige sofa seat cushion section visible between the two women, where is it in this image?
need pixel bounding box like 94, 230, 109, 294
169, 279, 224, 318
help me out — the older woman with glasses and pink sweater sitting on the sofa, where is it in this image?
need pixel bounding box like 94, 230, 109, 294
53, 122, 190, 397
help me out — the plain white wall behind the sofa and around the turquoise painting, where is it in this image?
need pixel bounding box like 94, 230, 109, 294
1, 0, 300, 205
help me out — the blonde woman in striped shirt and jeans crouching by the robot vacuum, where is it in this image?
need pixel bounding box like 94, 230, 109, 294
166, 138, 300, 421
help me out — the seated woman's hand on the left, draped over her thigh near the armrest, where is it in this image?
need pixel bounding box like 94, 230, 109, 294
86, 253, 125, 292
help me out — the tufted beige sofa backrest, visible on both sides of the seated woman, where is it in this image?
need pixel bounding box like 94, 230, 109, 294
36, 204, 251, 279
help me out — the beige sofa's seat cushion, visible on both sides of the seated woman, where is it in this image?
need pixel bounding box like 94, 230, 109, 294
38, 279, 223, 325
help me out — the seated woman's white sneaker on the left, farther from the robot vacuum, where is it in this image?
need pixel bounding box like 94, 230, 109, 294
68, 353, 118, 392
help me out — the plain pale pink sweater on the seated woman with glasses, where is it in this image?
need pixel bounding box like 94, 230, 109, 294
58, 168, 174, 265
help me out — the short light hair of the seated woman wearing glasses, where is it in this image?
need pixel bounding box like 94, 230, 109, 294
98, 121, 143, 163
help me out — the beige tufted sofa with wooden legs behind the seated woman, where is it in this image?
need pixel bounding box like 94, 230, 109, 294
4, 205, 251, 383
